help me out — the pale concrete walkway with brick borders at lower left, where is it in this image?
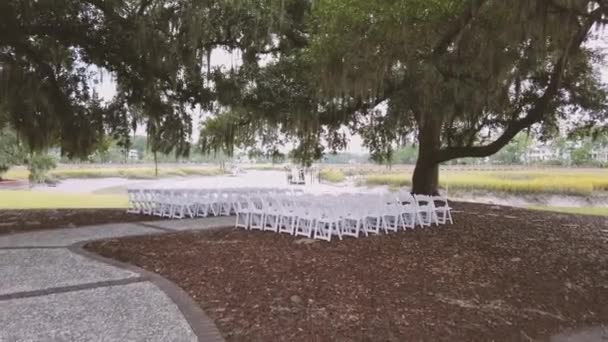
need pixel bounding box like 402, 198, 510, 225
0, 217, 234, 342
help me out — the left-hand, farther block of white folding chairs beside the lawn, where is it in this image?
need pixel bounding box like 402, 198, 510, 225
127, 188, 302, 219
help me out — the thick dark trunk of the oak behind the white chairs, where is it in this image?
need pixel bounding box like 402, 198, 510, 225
412, 117, 441, 195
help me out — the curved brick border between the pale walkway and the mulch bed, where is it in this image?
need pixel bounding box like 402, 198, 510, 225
67, 231, 225, 342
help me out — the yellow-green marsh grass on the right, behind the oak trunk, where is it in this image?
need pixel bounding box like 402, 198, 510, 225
364, 170, 608, 196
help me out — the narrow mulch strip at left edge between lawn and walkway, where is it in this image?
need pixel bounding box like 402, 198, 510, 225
0, 209, 145, 235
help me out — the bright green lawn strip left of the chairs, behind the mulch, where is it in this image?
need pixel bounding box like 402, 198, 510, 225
0, 190, 128, 209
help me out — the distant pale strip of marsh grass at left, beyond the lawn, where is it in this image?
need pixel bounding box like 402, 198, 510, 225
3, 166, 222, 179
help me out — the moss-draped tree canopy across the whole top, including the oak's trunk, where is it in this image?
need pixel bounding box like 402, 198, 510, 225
0, 0, 608, 193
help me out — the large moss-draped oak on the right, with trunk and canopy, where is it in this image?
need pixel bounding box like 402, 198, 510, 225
203, 0, 608, 194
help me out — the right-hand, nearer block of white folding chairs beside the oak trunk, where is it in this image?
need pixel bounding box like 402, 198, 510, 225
235, 192, 453, 241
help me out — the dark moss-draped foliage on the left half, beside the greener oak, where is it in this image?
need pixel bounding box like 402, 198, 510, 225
0, 0, 302, 158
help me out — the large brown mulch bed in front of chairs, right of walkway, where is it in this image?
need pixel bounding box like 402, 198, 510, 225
87, 204, 608, 341
